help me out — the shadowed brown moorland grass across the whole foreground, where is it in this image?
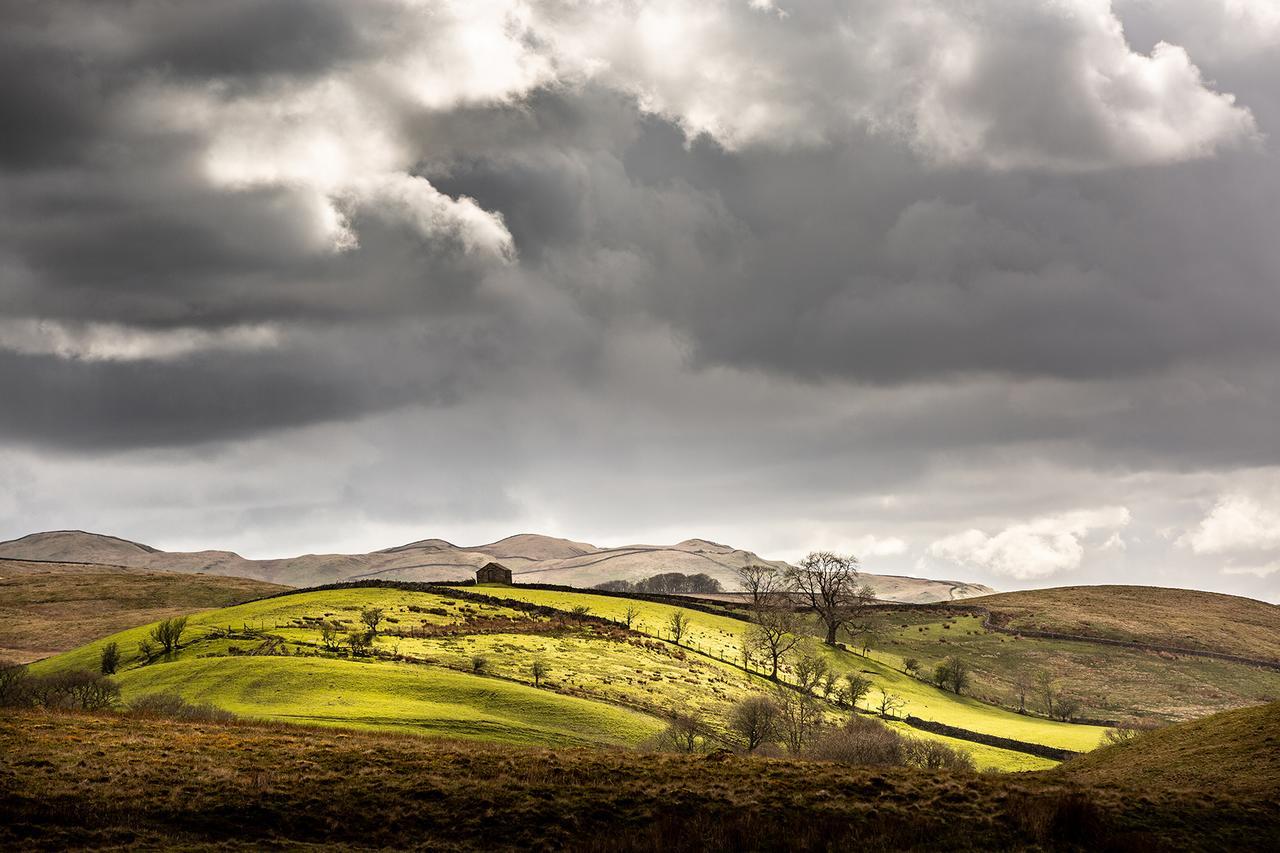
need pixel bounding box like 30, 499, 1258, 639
0, 712, 1280, 850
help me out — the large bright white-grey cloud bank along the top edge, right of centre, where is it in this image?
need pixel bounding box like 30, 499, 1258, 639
521, 0, 1256, 170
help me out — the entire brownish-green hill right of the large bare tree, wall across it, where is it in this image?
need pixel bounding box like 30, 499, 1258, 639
869, 587, 1280, 722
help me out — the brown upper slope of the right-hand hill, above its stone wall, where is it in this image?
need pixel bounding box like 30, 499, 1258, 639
964, 585, 1280, 661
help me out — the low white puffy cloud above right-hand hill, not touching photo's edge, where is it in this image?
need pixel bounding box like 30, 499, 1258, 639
928, 506, 1130, 580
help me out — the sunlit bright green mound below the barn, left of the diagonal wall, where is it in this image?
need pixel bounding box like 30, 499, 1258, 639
32, 588, 1049, 770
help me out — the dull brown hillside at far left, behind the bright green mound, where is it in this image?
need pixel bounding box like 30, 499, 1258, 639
0, 560, 288, 662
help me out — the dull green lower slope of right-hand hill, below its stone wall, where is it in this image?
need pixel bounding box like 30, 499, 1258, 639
872, 601, 1280, 721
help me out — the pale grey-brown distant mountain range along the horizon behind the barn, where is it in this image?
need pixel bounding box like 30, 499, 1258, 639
0, 530, 993, 603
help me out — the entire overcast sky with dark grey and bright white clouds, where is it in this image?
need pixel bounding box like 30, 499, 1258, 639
0, 0, 1280, 601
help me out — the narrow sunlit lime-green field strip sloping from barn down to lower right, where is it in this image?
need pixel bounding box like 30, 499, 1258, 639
458, 585, 1105, 752
